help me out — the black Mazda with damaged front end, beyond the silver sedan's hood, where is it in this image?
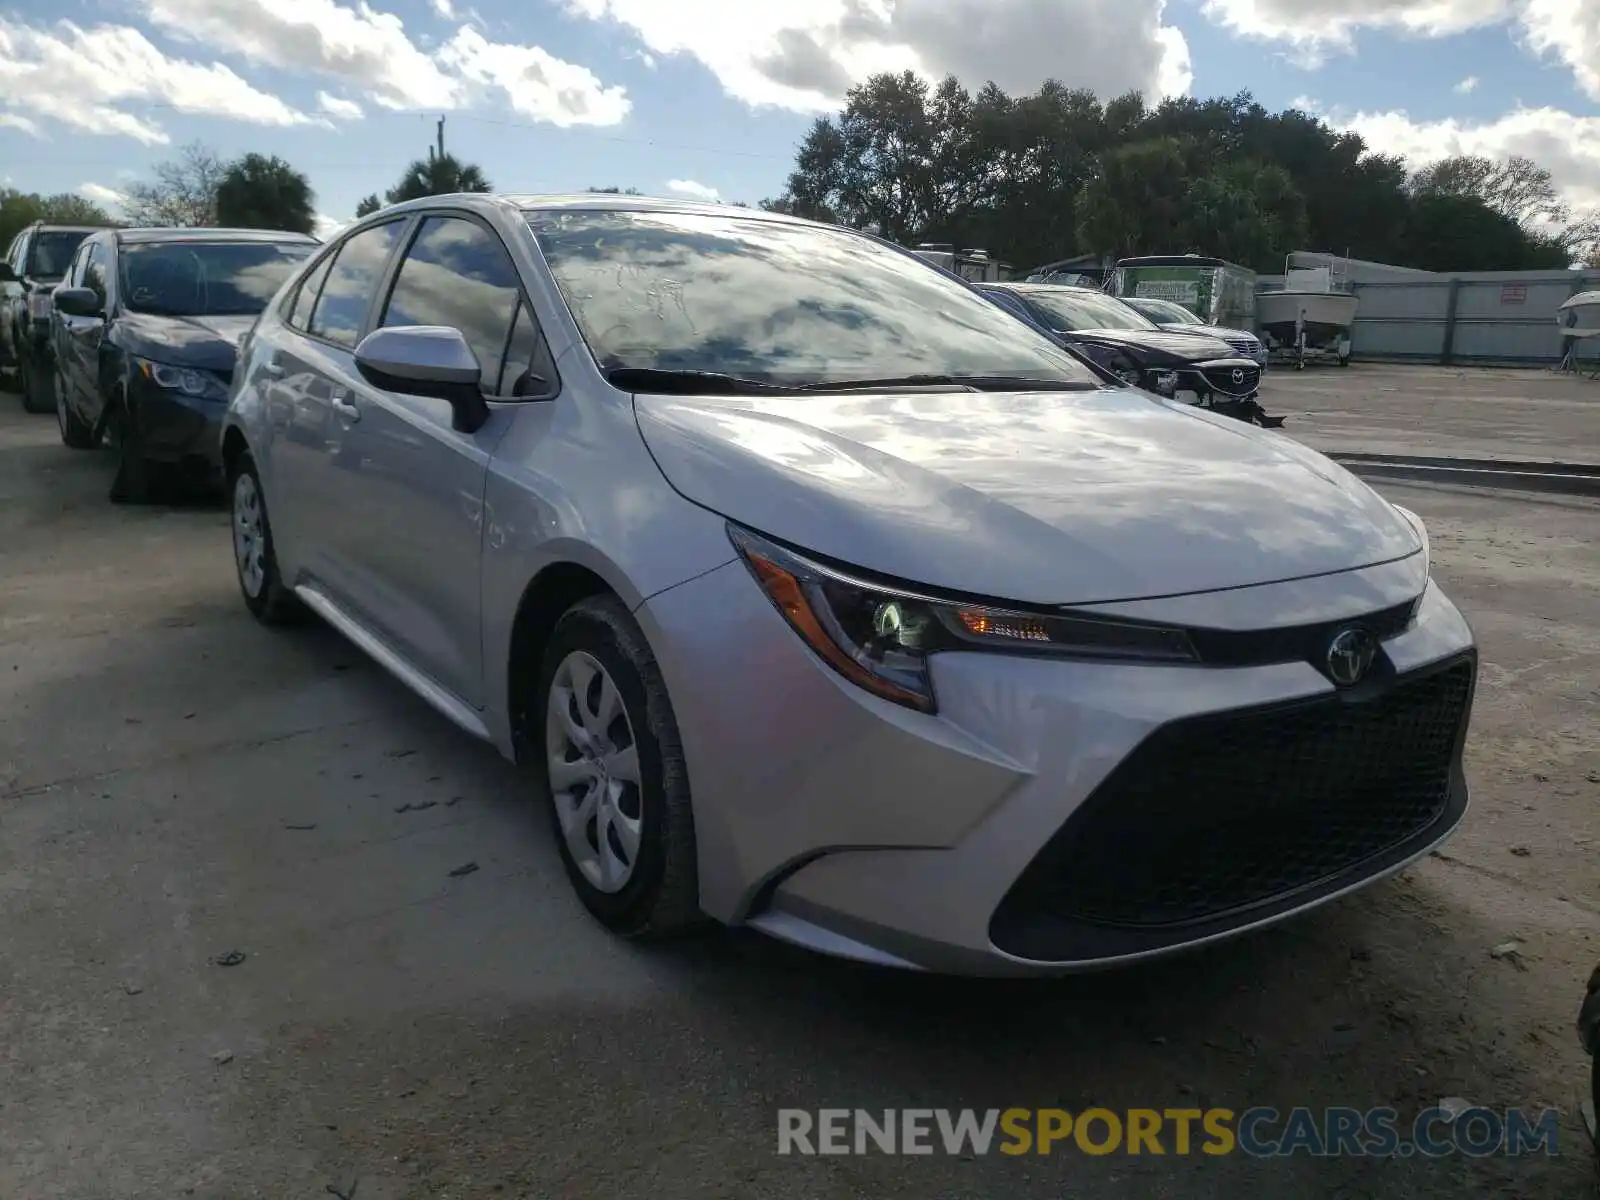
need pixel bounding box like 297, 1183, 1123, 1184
978, 283, 1283, 427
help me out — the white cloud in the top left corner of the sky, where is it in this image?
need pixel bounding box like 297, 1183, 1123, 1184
0, 18, 310, 144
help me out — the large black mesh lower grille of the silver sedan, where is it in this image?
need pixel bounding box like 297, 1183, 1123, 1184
992, 656, 1475, 934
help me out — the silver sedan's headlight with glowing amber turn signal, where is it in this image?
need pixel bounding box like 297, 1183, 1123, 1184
728, 523, 1198, 712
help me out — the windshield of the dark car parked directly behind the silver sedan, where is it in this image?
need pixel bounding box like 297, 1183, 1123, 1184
122, 242, 317, 317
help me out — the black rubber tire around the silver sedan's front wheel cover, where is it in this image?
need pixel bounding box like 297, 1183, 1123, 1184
526, 595, 706, 939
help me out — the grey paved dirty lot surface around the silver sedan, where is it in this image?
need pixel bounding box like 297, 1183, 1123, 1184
0, 366, 1600, 1200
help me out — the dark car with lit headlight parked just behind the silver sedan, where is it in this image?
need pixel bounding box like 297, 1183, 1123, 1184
51, 229, 318, 502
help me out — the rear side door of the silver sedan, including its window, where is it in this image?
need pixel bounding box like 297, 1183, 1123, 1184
265, 218, 410, 605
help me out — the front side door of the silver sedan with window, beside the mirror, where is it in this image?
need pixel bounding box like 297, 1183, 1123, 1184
318, 211, 537, 707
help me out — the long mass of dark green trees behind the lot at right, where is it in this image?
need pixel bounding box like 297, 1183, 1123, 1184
774, 74, 1600, 272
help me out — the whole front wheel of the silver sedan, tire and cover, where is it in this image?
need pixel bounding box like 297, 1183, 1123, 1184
531, 597, 702, 938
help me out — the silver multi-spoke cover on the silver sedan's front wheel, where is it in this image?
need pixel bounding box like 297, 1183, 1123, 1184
544, 650, 643, 893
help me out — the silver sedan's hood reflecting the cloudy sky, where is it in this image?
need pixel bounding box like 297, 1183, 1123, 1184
635, 389, 1422, 604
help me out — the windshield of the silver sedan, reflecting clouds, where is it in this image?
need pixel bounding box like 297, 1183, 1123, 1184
528, 210, 1098, 387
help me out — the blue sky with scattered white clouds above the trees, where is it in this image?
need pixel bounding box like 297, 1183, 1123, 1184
0, 0, 1600, 233
